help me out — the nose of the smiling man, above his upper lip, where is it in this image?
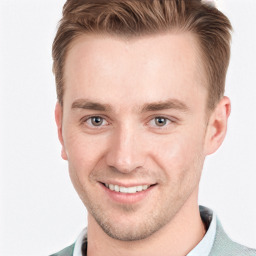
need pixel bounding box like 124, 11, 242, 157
106, 125, 146, 173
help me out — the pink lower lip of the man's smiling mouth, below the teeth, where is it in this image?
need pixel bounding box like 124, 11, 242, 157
100, 183, 156, 204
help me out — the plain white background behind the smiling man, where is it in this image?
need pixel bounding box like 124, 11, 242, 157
0, 0, 256, 256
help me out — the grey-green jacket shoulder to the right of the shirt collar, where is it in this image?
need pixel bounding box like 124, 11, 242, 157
210, 219, 256, 256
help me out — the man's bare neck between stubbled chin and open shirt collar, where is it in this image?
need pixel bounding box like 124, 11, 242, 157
87, 192, 205, 256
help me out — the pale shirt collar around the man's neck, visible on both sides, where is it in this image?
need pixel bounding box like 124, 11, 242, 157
73, 206, 217, 256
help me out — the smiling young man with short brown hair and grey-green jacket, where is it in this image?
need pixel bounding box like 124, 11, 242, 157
53, 0, 256, 256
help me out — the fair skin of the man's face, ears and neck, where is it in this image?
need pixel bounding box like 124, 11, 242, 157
55, 32, 230, 256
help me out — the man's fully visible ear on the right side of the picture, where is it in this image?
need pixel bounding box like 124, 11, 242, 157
205, 96, 231, 155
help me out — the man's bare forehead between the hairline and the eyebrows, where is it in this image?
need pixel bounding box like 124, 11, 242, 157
64, 32, 205, 110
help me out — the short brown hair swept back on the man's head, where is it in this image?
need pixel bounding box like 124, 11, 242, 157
52, 0, 232, 109
